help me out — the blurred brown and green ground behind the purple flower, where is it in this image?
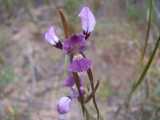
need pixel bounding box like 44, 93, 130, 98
0, 0, 160, 120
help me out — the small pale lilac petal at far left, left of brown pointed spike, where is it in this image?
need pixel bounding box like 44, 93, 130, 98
44, 26, 59, 45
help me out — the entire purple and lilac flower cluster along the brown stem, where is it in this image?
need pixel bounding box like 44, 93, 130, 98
45, 7, 99, 117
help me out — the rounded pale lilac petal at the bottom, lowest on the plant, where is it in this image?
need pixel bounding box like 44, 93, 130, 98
57, 97, 72, 114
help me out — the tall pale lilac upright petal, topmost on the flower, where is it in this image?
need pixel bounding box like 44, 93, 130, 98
78, 7, 96, 33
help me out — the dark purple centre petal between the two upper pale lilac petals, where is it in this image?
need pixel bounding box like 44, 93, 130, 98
63, 34, 86, 53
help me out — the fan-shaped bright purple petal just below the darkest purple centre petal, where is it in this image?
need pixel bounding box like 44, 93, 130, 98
68, 58, 91, 72
